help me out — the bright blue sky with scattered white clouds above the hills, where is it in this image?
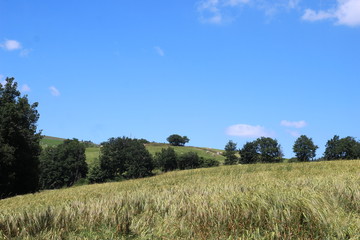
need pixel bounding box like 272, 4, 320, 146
0, 0, 360, 157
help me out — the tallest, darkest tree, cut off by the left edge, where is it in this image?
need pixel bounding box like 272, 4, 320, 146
0, 78, 41, 198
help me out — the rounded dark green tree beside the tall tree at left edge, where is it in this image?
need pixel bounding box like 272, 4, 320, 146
39, 139, 88, 189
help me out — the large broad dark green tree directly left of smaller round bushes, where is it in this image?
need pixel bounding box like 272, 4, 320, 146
100, 137, 153, 180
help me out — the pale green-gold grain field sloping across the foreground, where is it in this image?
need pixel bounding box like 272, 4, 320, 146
0, 160, 360, 239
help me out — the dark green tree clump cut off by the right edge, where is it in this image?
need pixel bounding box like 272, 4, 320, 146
324, 135, 360, 160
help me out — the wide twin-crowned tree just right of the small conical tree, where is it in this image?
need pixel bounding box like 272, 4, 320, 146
239, 137, 282, 163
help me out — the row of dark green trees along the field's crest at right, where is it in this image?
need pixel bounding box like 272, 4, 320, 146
223, 135, 360, 165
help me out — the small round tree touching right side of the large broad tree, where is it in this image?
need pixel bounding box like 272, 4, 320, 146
154, 147, 178, 172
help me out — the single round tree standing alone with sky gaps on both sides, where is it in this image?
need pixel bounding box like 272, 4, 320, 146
293, 135, 319, 162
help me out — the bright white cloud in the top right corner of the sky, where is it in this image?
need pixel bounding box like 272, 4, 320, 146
302, 0, 360, 26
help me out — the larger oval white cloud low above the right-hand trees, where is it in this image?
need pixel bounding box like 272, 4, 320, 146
226, 124, 273, 137
